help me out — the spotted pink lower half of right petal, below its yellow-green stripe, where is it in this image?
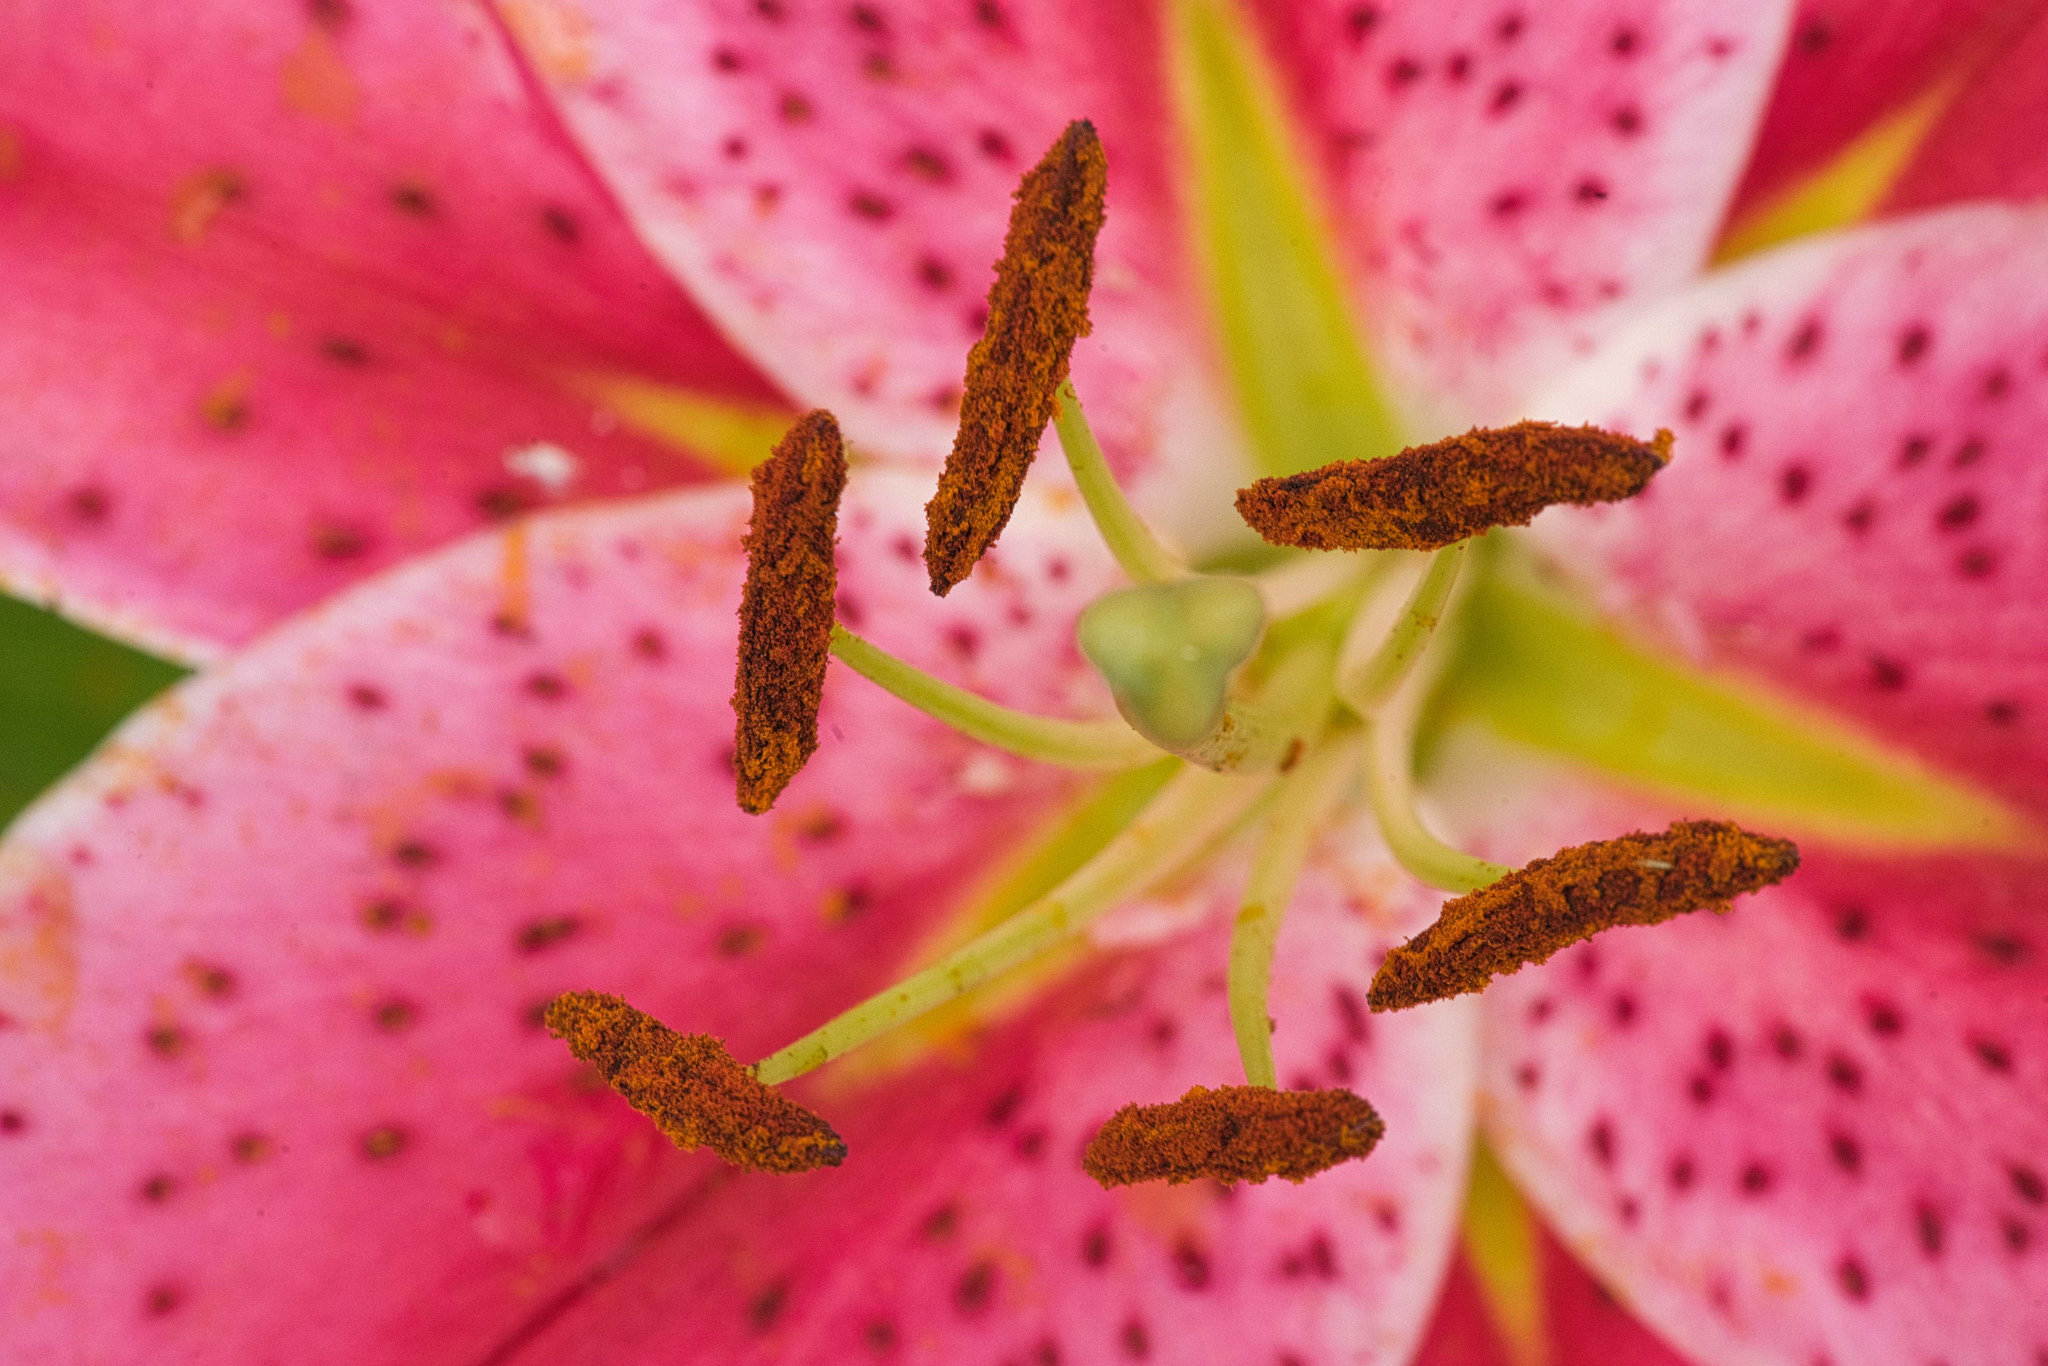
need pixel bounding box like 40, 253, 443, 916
1483, 795, 2048, 1366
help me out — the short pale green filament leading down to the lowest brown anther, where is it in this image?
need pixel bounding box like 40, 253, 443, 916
1231, 731, 1362, 1085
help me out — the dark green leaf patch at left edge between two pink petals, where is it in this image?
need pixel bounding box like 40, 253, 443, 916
0, 596, 184, 823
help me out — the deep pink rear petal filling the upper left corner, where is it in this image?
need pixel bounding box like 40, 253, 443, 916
0, 0, 768, 657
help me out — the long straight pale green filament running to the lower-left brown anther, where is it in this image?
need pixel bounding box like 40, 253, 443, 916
754, 768, 1270, 1085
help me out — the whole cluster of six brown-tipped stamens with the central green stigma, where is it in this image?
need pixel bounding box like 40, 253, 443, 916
549, 123, 1796, 1184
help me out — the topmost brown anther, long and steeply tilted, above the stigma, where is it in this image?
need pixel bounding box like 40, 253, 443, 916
924, 121, 1108, 596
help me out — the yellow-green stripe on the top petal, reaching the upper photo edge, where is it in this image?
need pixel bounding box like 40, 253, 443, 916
1169, 0, 1407, 475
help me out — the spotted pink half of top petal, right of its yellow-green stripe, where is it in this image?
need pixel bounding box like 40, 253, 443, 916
1257, 0, 1788, 434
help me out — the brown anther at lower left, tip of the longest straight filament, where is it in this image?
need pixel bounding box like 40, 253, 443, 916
547, 991, 846, 1171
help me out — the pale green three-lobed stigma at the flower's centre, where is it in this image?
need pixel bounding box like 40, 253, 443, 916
1075, 575, 1266, 754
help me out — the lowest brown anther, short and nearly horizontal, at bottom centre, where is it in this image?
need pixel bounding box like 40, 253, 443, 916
1081, 1085, 1386, 1188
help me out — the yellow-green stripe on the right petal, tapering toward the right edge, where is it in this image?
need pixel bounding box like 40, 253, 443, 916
1436, 557, 2042, 850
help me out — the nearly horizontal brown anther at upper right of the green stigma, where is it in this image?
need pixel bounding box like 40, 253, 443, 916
1237, 422, 1671, 551
